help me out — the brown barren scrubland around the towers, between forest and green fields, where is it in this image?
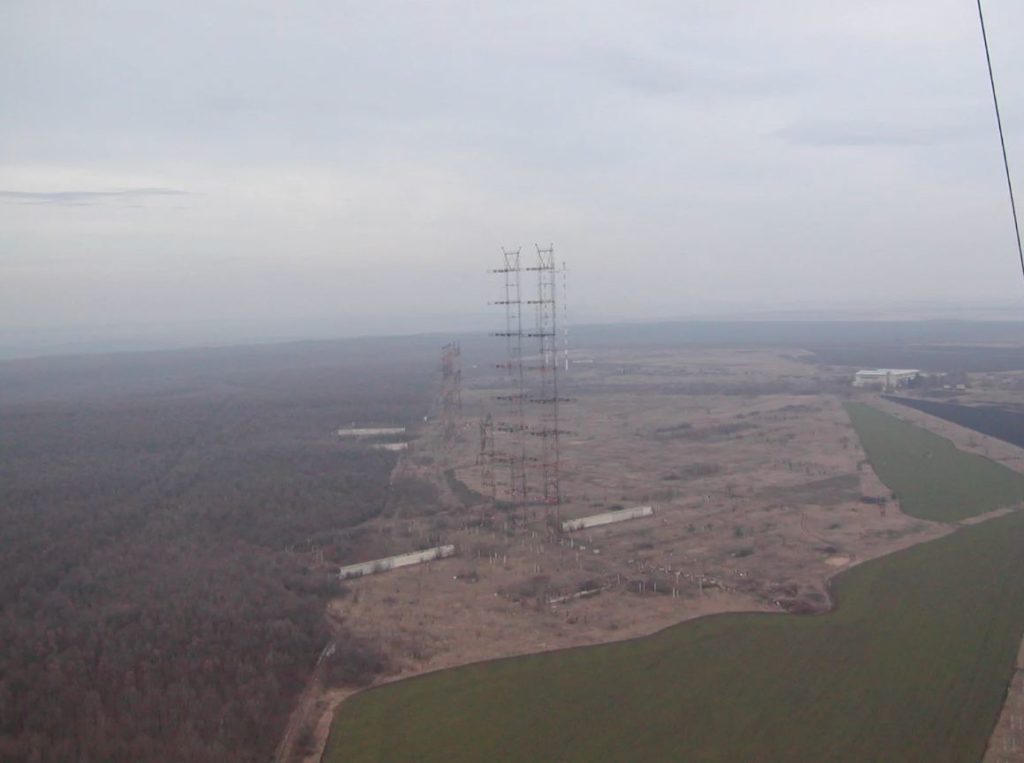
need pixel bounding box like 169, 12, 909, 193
280, 349, 1024, 763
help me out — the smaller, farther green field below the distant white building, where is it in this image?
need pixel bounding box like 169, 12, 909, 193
846, 402, 1024, 521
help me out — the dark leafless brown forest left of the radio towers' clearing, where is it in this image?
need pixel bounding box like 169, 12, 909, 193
0, 343, 434, 763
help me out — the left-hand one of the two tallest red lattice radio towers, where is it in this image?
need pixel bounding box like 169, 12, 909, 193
492, 248, 528, 506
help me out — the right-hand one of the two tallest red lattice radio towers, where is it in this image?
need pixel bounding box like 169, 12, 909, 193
526, 246, 565, 517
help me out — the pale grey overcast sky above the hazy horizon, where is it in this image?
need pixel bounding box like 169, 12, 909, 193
0, 0, 1024, 350
